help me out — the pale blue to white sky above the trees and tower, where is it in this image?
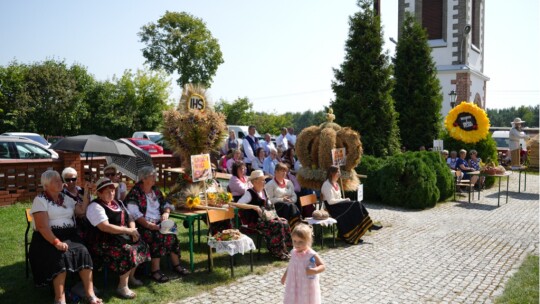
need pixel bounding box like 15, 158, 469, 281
0, 0, 540, 113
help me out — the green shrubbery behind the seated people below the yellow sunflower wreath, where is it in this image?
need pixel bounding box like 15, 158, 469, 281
441, 132, 498, 187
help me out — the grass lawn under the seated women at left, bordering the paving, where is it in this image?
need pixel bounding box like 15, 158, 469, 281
0, 203, 304, 303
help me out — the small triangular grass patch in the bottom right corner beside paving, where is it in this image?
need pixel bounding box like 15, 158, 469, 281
495, 255, 539, 304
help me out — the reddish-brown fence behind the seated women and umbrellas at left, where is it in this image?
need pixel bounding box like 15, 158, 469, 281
0, 152, 180, 206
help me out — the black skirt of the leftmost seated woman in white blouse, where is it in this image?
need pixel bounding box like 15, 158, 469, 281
29, 228, 93, 286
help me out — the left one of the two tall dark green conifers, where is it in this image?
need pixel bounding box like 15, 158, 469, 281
331, 0, 399, 156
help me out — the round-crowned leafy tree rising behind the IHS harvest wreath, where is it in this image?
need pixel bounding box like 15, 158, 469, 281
139, 11, 224, 87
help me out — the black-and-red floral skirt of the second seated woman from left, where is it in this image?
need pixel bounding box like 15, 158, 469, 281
91, 235, 150, 275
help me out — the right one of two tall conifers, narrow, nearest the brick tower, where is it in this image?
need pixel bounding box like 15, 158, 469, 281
392, 13, 442, 150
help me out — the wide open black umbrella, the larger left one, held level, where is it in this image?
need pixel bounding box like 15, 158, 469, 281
51, 134, 135, 157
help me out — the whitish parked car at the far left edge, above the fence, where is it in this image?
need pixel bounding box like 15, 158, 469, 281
0, 134, 58, 159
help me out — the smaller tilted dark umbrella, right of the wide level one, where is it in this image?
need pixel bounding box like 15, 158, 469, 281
105, 139, 153, 181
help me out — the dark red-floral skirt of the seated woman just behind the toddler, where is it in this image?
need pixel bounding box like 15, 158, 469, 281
256, 217, 292, 258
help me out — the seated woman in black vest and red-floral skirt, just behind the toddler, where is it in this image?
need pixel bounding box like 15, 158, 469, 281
234, 170, 292, 260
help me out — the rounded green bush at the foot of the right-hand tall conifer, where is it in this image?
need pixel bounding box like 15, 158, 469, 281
378, 153, 440, 209
